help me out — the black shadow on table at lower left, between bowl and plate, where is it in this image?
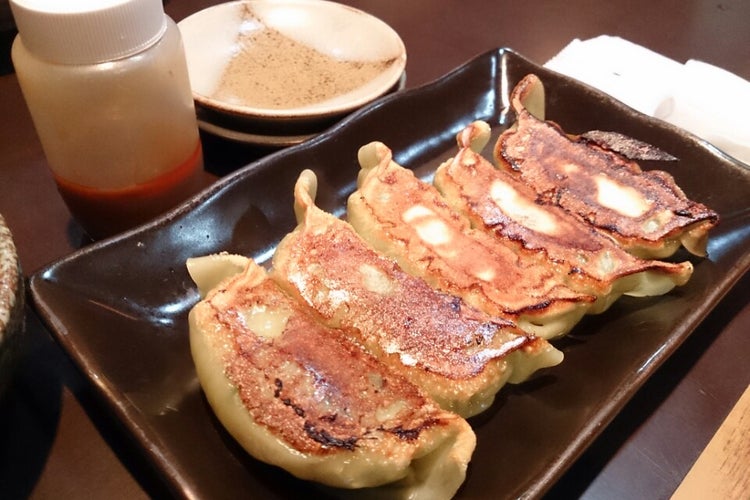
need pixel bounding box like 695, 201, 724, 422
0, 310, 175, 500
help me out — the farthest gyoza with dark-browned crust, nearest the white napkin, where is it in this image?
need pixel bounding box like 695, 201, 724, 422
493, 75, 719, 258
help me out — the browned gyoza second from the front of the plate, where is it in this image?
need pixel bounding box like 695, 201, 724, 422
271, 170, 562, 416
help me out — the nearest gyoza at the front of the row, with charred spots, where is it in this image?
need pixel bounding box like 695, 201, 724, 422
187, 255, 476, 500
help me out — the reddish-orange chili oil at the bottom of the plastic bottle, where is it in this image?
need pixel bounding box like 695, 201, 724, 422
55, 142, 203, 239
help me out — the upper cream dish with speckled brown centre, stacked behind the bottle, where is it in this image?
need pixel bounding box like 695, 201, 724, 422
178, 0, 406, 131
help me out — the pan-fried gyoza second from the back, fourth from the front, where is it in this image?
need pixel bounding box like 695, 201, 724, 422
434, 122, 693, 313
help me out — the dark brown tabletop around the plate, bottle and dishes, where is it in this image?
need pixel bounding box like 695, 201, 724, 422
0, 0, 750, 499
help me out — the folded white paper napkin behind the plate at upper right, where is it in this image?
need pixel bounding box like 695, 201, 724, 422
545, 35, 750, 164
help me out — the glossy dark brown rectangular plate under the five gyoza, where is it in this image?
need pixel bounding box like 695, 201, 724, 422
31, 49, 750, 498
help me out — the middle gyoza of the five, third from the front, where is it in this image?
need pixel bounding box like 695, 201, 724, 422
348, 142, 595, 339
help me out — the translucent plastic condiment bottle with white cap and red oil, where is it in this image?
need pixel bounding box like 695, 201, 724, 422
11, 0, 203, 238
